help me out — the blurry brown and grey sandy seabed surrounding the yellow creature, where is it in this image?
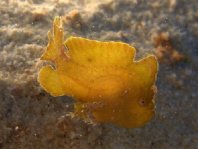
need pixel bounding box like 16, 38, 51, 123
0, 0, 198, 149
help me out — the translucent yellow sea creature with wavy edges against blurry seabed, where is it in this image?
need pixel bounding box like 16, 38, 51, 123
38, 17, 158, 128
